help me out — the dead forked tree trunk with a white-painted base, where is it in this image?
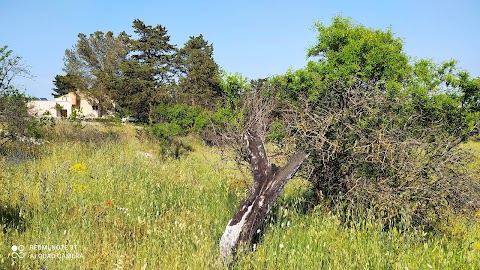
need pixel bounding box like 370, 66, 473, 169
220, 131, 308, 263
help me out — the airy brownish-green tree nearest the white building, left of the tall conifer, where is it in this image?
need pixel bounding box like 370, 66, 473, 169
61, 31, 128, 115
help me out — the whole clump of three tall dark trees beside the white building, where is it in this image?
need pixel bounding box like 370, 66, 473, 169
54, 19, 225, 123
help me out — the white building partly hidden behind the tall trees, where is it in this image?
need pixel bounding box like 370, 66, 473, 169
28, 92, 109, 118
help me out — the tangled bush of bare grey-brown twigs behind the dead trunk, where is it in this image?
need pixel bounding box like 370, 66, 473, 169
283, 78, 480, 232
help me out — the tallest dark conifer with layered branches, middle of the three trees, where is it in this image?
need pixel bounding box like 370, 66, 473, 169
115, 19, 178, 123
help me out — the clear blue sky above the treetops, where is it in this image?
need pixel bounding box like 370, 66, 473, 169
0, 0, 480, 98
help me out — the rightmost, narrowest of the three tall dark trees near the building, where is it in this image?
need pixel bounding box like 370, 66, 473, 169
179, 35, 221, 109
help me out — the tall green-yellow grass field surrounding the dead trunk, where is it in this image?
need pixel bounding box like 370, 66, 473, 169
0, 126, 480, 270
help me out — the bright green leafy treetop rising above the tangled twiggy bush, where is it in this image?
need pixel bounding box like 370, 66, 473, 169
307, 16, 410, 89
